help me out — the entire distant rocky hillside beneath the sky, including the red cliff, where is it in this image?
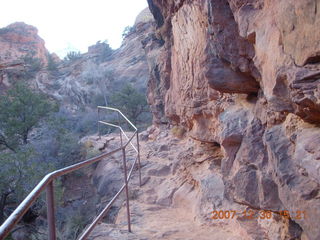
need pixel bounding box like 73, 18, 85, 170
0, 9, 154, 111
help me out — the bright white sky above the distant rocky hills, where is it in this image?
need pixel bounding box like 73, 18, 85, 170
0, 0, 148, 58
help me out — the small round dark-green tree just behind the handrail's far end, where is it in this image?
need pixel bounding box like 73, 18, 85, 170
110, 84, 149, 124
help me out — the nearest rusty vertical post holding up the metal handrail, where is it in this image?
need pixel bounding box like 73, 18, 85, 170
47, 181, 56, 240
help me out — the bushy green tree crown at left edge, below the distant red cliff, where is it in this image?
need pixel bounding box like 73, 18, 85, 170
0, 83, 57, 151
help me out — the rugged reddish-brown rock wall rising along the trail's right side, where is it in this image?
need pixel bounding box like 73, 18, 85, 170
143, 0, 320, 239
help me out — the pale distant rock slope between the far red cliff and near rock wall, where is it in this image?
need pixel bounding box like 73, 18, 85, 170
50, 10, 155, 109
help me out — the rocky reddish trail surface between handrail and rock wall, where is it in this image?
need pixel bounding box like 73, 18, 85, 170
85, 126, 288, 240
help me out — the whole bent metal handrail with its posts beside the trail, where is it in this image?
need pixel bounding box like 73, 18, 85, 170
0, 106, 141, 240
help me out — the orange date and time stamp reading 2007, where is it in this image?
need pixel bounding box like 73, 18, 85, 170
210, 209, 307, 220
